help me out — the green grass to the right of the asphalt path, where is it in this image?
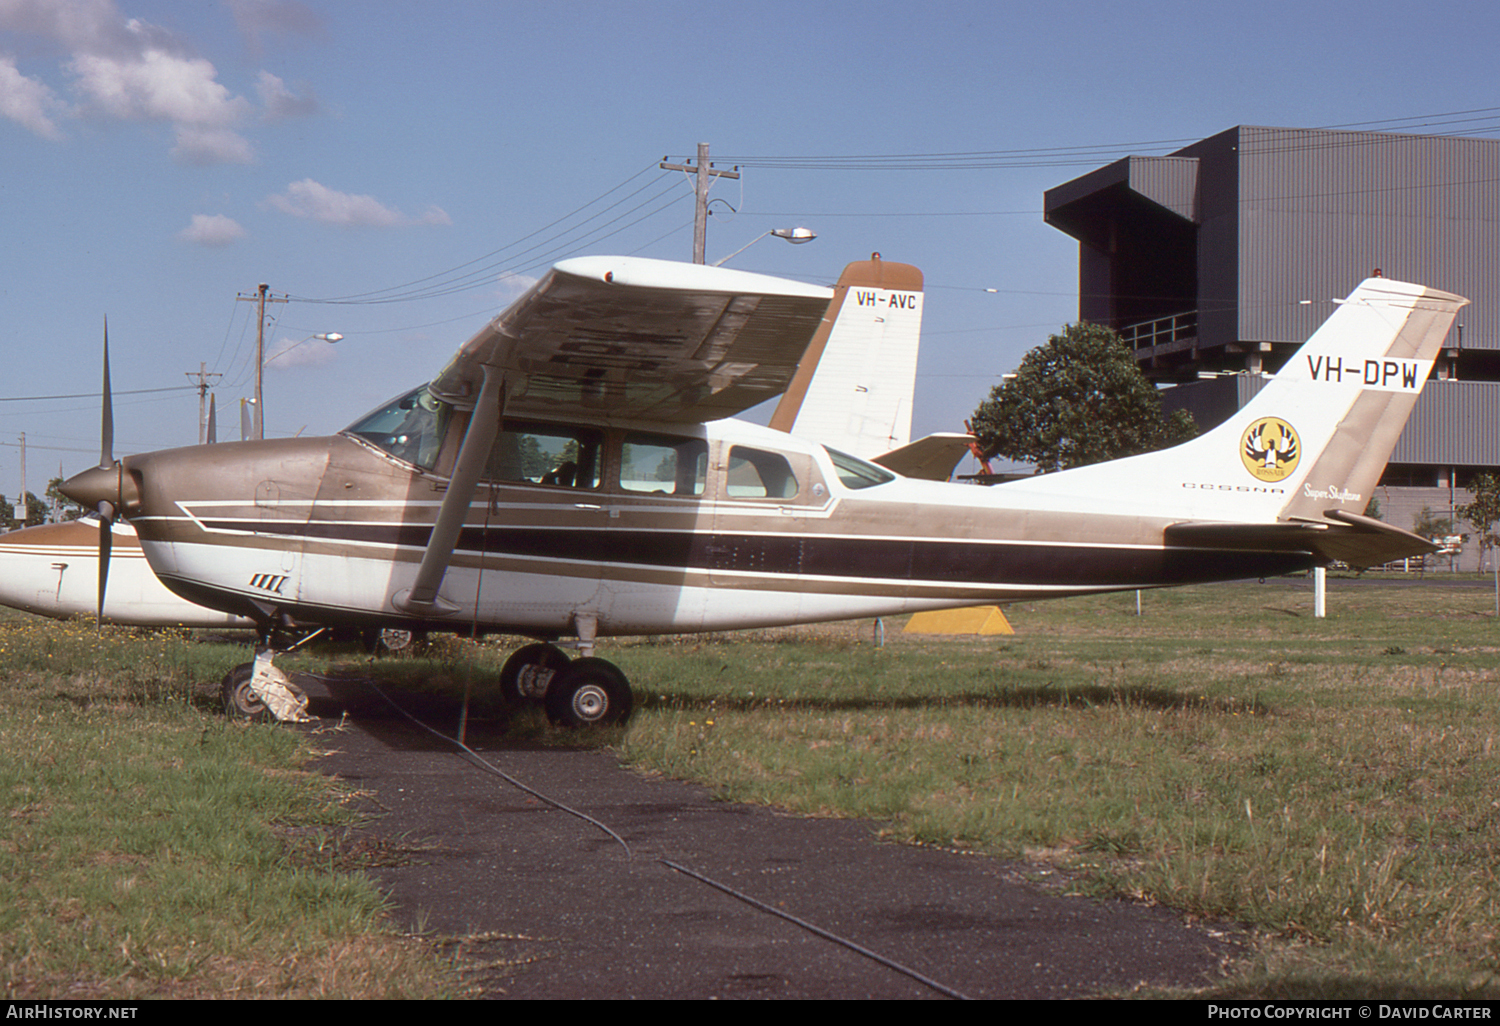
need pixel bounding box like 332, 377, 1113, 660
594, 582, 1500, 996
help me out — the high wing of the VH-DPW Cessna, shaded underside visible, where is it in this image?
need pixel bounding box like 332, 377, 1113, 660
431, 257, 833, 423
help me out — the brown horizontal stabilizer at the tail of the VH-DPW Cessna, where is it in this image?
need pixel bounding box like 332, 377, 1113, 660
1167, 510, 1437, 567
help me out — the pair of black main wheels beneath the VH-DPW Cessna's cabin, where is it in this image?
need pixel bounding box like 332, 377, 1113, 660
500, 644, 635, 726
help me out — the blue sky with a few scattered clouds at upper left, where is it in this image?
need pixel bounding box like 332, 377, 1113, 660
0, 0, 1500, 497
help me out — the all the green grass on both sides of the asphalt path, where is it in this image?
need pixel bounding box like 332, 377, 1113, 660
0, 581, 1500, 998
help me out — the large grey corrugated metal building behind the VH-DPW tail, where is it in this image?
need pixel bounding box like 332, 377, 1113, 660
1046, 126, 1500, 569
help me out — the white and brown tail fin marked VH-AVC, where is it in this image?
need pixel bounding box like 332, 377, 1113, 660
771, 254, 923, 459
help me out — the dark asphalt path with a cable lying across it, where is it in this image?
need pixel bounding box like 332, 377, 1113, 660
300, 681, 1238, 999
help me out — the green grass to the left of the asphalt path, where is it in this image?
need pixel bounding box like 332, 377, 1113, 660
0, 615, 449, 999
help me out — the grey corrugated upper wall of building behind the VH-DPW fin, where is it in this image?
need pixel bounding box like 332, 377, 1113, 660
1182, 126, 1500, 350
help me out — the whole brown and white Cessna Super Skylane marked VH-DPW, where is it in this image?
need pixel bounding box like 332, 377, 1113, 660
63, 257, 1466, 723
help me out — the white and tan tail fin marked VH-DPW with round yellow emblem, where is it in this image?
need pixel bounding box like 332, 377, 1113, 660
1004, 278, 1469, 558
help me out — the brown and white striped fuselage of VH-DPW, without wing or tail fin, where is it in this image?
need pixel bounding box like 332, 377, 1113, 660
96, 405, 1314, 638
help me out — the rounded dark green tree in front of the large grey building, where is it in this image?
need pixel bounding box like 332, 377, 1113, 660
969, 323, 1199, 474
